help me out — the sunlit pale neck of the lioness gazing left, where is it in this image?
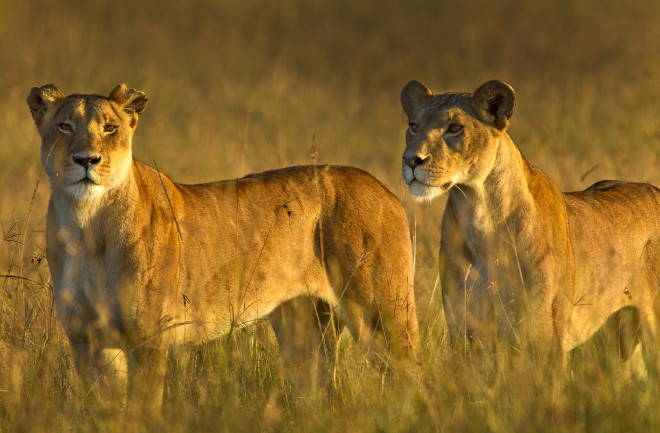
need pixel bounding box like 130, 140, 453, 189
449, 133, 535, 240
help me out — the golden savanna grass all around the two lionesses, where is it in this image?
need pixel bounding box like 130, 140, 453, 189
0, 0, 660, 432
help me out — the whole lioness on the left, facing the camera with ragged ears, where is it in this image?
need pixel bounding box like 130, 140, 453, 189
27, 84, 418, 408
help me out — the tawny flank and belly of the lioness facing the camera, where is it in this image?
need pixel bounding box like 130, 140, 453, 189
160, 165, 368, 343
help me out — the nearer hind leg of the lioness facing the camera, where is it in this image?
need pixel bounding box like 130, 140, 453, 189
325, 226, 419, 372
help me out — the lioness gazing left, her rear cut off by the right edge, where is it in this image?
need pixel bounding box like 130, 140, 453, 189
401, 81, 660, 368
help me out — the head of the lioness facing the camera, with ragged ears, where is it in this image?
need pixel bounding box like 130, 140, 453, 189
27, 84, 147, 200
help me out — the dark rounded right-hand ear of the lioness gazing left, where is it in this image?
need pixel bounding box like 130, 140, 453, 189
472, 80, 516, 131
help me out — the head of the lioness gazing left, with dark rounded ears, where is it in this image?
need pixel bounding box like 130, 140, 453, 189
401, 81, 515, 200
